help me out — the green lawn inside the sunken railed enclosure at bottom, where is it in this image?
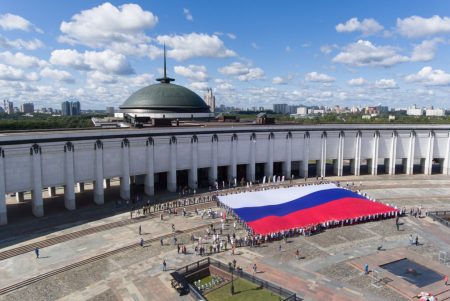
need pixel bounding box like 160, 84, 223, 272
205, 278, 281, 301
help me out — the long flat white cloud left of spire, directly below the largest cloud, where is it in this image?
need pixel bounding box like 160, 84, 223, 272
50, 49, 134, 75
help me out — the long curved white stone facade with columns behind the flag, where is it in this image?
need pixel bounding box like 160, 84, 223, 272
0, 125, 450, 224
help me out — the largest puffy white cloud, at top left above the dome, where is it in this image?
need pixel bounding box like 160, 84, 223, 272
59, 2, 158, 47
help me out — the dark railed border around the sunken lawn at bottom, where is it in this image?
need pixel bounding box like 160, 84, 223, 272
170, 257, 302, 301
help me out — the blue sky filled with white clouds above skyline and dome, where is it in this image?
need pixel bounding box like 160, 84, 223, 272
0, 0, 450, 109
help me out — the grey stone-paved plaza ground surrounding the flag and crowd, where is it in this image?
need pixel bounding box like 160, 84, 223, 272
0, 175, 450, 300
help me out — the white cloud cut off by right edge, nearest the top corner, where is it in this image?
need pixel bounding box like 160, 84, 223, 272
397, 15, 450, 38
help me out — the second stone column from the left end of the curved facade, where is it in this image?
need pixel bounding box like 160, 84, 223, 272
30, 144, 44, 217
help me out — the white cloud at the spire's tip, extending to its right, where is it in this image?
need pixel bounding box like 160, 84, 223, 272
156, 33, 236, 61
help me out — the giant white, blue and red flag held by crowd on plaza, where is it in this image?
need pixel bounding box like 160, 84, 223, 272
219, 184, 397, 234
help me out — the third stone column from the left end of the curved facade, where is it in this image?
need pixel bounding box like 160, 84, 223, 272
64, 142, 75, 210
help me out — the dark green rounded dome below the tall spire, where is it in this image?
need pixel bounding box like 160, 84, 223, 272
120, 82, 210, 113
